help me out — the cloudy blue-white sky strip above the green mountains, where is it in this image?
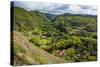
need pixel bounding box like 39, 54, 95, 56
14, 1, 97, 15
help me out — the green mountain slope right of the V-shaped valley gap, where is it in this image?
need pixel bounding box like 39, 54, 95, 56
53, 13, 97, 32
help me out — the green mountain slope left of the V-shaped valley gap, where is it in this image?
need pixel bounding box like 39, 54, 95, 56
13, 7, 49, 33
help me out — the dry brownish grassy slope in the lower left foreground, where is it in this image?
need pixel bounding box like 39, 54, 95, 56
13, 31, 67, 65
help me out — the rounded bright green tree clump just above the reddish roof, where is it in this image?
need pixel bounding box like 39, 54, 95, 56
56, 36, 83, 49
